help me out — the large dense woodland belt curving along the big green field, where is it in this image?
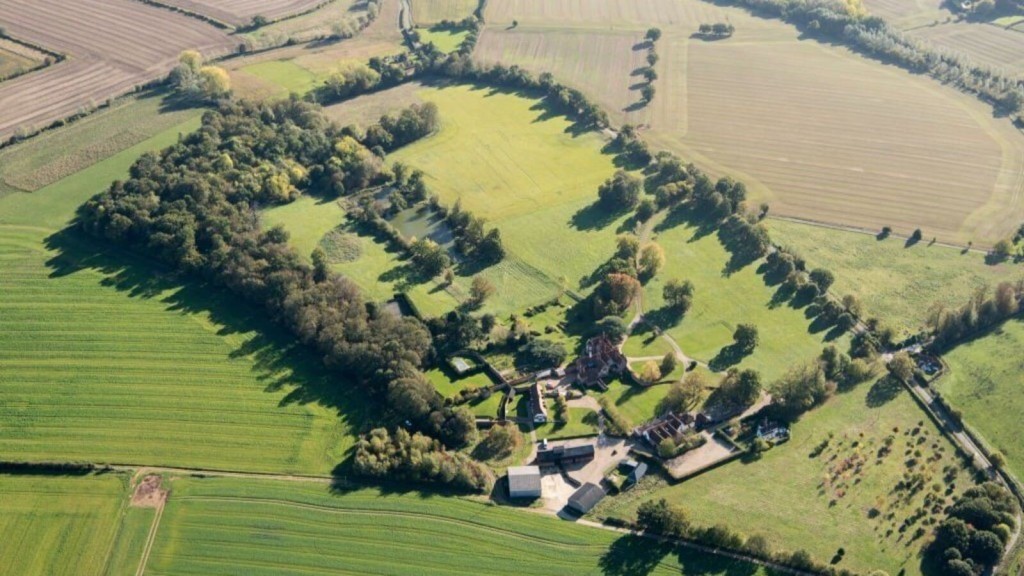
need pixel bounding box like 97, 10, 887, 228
79, 99, 472, 445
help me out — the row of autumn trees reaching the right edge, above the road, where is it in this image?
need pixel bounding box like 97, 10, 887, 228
928, 282, 1024, 349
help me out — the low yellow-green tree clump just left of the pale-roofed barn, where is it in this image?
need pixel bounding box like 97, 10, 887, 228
354, 428, 494, 493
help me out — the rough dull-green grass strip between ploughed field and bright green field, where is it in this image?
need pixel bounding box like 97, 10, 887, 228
0, 92, 203, 197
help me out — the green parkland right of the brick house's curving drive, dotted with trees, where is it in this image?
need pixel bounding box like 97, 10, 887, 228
641, 211, 845, 383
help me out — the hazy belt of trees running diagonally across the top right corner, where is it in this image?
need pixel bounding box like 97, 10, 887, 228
734, 0, 1024, 114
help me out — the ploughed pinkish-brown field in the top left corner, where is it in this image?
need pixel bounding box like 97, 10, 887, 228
0, 0, 238, 138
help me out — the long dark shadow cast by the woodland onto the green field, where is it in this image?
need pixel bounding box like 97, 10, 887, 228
45, 228, 381, 453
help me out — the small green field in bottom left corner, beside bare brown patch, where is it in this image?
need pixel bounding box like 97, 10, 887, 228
0, 474, 132, 576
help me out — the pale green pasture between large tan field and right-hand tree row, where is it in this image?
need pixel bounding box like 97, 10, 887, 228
769, 219, 1024, 334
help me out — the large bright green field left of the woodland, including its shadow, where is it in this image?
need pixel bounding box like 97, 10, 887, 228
0, 119, 366, 474
